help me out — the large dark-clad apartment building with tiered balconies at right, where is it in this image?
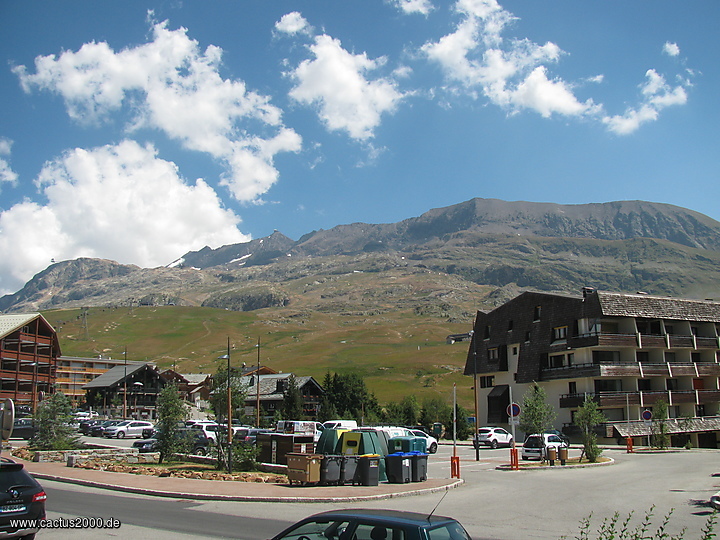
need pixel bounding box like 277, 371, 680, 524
465, 288, 720, 448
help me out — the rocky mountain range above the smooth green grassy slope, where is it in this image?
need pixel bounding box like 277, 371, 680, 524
0, 199, 720, 321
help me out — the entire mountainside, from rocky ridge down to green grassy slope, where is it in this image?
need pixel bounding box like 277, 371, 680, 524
7, 199, 720, 405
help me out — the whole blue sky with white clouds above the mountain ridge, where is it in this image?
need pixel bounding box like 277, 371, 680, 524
0, 0, 720, 294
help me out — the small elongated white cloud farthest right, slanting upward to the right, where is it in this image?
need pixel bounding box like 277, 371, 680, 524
602, 69, 687, 135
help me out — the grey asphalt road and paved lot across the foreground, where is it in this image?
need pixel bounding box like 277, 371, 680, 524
38, 446, 720, 540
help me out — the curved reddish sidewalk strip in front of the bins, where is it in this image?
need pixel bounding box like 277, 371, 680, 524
18, 457, 463, 502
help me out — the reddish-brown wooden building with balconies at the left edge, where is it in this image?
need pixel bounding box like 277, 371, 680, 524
0, 313, 60, 412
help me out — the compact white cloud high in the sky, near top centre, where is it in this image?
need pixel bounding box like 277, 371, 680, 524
290, 35, 404, 140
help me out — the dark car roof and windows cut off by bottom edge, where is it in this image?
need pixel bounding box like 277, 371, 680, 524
271, 509, 470, 540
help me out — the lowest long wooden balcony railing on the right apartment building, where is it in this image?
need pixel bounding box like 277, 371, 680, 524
560, 390, 720, 409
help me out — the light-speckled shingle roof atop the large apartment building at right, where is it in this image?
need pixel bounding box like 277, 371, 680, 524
596, 291, 720, 322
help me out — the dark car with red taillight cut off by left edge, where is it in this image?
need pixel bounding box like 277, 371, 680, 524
0, 458, 47, 538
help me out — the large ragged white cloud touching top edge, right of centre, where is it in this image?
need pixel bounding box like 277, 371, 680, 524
422, 0, 596, 117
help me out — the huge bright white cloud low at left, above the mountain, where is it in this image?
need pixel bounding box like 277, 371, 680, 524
0, 141, 249, 293
